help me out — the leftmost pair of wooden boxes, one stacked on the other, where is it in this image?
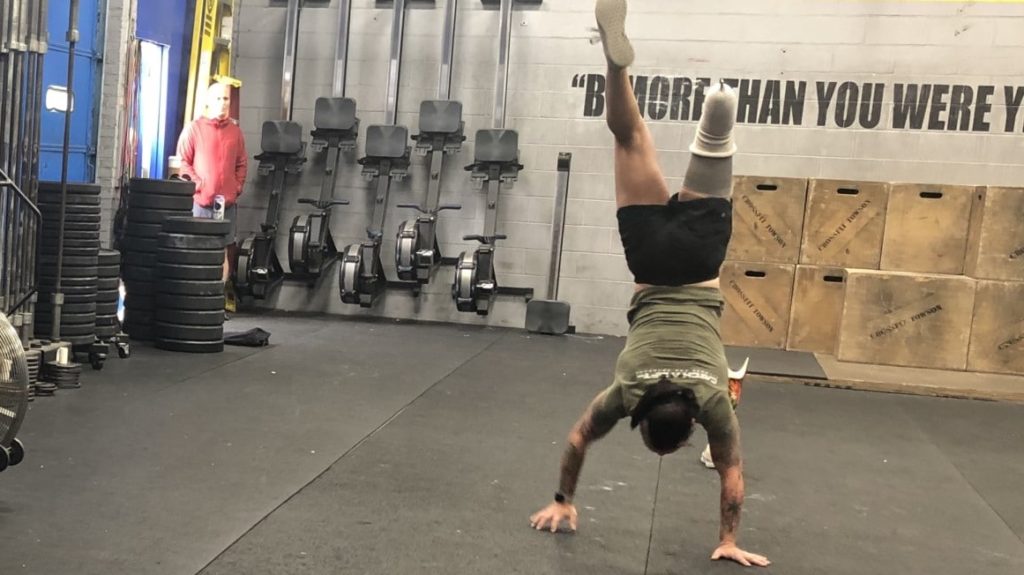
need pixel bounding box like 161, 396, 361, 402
721, 176, 807, 349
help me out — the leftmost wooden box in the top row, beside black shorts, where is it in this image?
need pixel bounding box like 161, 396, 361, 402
726, 176, 807, 264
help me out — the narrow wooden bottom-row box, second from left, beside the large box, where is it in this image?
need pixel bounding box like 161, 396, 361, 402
785, 266, 846, 354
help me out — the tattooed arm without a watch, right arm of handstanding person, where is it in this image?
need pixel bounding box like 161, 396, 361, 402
708, 413, 771, 567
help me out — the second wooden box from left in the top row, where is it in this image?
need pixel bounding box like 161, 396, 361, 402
800, 179, 889, 269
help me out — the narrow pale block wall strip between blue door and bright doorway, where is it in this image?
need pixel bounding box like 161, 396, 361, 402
95, 0, 137, 247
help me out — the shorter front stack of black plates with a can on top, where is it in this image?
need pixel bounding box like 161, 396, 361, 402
154, 218, 230, 353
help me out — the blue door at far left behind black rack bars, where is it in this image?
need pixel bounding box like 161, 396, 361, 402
39, 0, 102, 182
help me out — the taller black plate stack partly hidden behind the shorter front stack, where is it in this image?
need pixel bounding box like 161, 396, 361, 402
121, 178, 196, 340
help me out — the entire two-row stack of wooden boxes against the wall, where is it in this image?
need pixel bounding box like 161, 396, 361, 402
721, 171, 1024, 373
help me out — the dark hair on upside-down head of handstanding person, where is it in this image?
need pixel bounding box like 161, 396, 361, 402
630, 378, 700, 451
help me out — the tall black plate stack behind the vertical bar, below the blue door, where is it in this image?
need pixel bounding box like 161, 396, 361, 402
35, 182, 99, 346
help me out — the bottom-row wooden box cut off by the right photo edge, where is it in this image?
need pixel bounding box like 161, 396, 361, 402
967, 281, 1024, 374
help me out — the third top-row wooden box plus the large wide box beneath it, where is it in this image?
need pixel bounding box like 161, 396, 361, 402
836, 184, 978, 369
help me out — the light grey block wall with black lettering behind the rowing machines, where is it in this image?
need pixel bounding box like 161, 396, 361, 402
236, 0, 1024, 335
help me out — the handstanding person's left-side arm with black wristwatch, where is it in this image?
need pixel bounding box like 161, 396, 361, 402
529, 390, 623, 532
